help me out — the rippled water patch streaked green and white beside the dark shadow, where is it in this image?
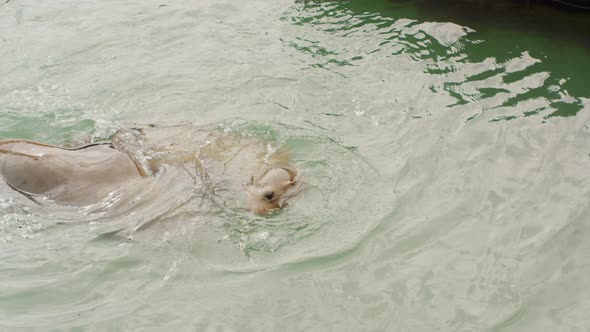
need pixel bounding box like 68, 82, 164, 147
283, 1, 585, 122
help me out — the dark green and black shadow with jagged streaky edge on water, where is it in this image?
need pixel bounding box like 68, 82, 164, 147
301, 0, 590, 121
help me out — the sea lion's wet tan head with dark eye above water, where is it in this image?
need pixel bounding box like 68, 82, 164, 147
246, 166, 298, 214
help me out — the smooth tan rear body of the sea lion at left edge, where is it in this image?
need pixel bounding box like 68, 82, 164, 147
0, 140, 142, 206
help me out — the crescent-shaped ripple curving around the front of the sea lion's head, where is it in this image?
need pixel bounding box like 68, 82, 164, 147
177, 122, 395, 271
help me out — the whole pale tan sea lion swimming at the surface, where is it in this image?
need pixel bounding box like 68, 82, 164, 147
0, 126, 300, 213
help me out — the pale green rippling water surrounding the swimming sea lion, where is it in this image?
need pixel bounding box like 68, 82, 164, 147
0, 0, 590, 331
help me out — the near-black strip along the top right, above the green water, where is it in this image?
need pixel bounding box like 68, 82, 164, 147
346, 0, 590, 49
